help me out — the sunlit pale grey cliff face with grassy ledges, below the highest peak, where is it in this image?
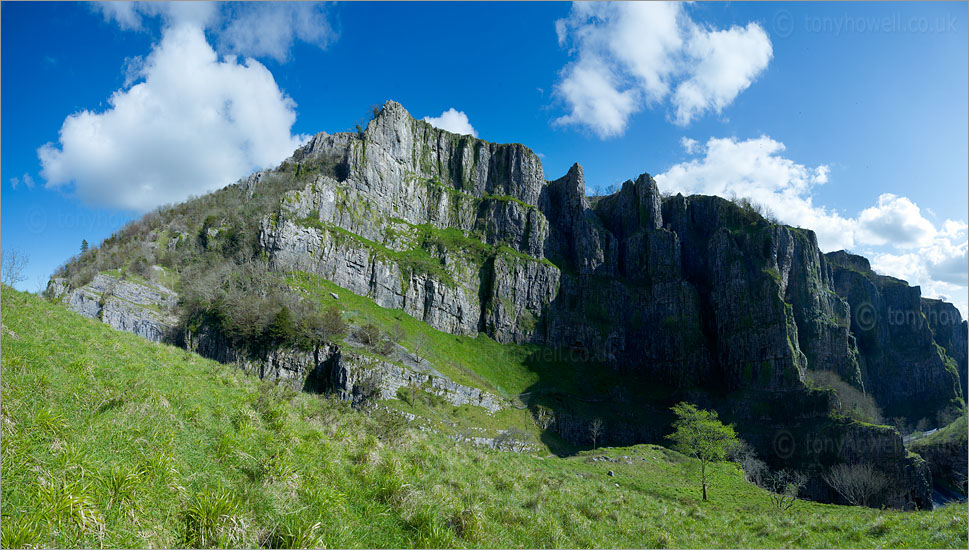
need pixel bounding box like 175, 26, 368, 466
260, 102, 558, 342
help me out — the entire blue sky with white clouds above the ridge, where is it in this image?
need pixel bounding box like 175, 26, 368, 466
0, 2, 969, 314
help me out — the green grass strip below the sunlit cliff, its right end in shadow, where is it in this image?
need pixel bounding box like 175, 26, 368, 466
288, 272, 670, 451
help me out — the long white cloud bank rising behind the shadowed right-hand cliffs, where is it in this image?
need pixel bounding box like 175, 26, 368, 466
656, 136, 969, 316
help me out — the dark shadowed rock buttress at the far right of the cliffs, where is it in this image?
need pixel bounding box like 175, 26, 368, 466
826, 251, 964, 424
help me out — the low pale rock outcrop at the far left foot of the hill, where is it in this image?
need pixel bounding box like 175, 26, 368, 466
47, 273, 178, 342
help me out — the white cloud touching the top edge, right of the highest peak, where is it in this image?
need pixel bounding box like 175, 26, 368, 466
555, 2, 773, 138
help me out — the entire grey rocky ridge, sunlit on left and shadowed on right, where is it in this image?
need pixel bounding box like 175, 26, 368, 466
51, 102, 967, 506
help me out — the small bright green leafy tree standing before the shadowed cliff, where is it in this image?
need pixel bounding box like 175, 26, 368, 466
666, 403, 738, 501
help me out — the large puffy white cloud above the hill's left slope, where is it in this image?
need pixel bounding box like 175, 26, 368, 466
38, 23, 305, 211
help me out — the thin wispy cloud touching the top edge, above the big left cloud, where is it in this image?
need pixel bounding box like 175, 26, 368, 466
95, 2, 335, 62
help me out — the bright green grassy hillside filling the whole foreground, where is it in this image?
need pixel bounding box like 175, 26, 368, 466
0, 287, 967, 547
